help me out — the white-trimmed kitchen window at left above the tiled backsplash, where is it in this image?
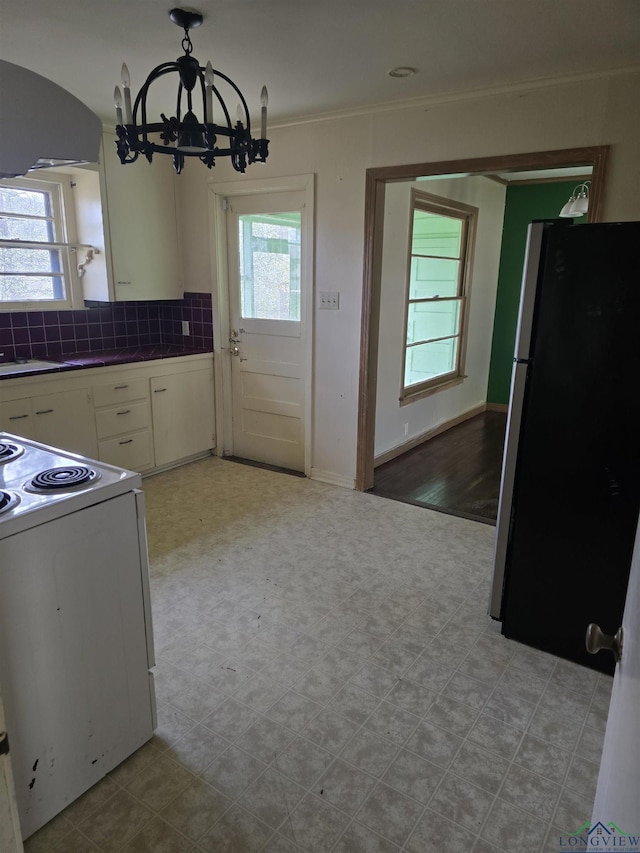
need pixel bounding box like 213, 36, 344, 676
0, 173, 83, 311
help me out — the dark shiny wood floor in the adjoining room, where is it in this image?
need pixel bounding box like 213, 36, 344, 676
370, 412, 507, 524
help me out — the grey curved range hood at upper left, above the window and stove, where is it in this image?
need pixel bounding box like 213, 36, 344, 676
0, 60, 102, 178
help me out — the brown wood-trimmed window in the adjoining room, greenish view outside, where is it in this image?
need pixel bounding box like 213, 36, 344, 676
401, 190, 477, 400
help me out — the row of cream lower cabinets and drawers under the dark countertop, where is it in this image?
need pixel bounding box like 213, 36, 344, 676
0, 355, 215, 473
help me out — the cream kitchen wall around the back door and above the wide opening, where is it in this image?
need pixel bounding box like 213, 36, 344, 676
177, 71, 640, 484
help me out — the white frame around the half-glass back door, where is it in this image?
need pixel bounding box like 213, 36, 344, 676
208, 174, 315, 477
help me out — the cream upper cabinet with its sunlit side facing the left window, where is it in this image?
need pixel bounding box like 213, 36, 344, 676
76, 131, 184, 302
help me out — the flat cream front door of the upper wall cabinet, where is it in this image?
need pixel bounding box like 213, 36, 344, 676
104, 128, 183, 300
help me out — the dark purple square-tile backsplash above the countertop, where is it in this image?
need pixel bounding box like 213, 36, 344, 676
0, 293, 213, 361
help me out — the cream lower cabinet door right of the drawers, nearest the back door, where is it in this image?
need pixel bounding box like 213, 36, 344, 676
151, 369, 215, 466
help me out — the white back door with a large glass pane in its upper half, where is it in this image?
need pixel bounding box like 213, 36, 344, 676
227, 193, 306, 471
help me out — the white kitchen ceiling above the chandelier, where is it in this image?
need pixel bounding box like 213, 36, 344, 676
0, 0, 640, 123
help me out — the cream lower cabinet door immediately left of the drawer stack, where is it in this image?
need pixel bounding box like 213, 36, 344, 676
31, 388, 97, 457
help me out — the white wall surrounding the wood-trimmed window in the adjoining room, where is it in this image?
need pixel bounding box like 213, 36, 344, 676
375, 176, 506, 457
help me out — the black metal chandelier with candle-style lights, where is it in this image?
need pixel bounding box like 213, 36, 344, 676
114, 9, 269, 174
